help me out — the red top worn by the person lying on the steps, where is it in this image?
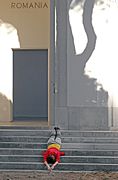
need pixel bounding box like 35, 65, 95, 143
43, 148, 65, 162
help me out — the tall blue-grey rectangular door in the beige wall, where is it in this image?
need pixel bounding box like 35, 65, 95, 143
13, 49, 48, 121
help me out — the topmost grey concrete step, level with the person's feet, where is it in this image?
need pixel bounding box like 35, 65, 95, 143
0, 128, 118, 138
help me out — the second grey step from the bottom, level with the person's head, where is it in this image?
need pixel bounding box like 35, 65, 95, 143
0, 155, 118, 164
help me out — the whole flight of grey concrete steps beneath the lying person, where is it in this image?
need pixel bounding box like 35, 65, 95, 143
0, 127, 118, 171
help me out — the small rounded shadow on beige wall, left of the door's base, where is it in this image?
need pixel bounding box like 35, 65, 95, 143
0, 93, 12, 122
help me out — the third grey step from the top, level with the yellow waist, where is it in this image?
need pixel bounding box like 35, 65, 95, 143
0, 142, 118, 151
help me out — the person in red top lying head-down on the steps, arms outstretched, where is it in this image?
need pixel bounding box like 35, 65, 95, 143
43, 127, 65, 171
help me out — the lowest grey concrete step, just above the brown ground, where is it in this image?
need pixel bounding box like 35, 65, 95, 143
0, 162, 118, 172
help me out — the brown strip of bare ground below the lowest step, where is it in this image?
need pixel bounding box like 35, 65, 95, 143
0, 172, 118, 180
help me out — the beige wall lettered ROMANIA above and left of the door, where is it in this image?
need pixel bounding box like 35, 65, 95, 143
0, 0, 50, 121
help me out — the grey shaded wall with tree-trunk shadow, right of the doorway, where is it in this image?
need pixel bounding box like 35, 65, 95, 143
55, 0, 109, 130
